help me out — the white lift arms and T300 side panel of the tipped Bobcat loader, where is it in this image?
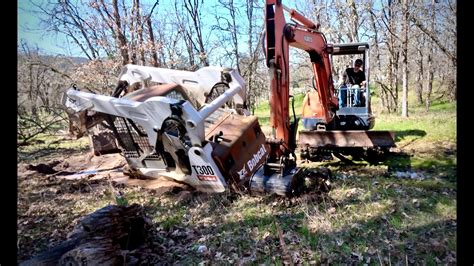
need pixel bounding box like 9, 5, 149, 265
62, 65, 245, 192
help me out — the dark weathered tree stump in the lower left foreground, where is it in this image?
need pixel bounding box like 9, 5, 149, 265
20, 204, 151, 265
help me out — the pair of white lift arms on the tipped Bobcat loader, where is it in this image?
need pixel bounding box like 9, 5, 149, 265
62, 65, 245, 147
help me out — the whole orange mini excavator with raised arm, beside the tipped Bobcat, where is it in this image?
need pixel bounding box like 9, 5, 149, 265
264, 0, 395, 162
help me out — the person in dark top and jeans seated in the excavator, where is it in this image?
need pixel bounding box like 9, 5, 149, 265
338, 59, 366, 107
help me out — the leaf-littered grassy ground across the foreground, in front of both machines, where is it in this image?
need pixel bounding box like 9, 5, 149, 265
17, 120, 457, 265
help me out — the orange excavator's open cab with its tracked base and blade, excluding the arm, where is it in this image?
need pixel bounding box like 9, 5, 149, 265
298, 42, 395, 162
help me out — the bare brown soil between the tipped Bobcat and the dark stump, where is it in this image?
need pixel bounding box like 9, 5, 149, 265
17, 150, 188, 261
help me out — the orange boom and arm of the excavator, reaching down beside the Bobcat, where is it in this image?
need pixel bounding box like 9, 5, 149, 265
265, 0, 338, 157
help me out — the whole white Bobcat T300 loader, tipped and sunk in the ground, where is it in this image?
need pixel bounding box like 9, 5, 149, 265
63, 65, 269, 192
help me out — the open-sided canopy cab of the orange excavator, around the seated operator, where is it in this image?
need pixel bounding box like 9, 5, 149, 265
331, 43, 375, 130
